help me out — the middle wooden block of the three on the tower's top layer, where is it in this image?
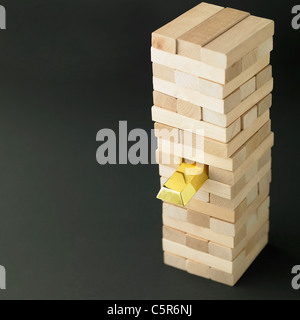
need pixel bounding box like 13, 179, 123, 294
177, 8, 249, 60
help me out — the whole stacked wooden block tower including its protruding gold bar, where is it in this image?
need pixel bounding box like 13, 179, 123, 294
151, 3, 274, 285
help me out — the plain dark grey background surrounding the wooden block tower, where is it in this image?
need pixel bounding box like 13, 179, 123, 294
0, 0, 300, 299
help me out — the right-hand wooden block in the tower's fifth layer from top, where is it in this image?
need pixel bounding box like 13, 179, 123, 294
202, 80, 273, 127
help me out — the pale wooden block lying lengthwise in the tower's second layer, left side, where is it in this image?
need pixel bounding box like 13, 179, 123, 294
151, 47, 227, 84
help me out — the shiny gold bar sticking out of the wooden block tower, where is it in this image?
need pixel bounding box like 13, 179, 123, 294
157, 162, 208, 207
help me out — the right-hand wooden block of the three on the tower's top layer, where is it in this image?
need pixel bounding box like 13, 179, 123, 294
201, 16, 274, 69
